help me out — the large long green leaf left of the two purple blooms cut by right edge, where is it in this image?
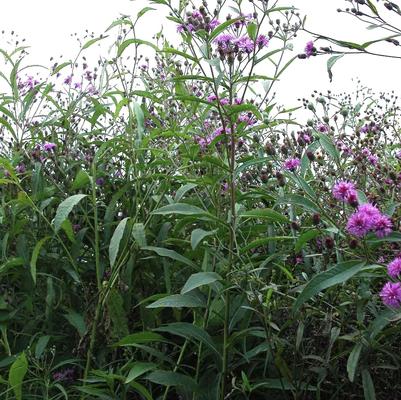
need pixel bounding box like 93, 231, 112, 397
293, 261, 365, 312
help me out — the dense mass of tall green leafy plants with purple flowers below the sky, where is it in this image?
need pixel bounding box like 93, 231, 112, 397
0, 0, 401, 400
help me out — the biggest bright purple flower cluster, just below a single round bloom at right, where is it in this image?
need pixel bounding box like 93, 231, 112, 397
347, 204, 393, 238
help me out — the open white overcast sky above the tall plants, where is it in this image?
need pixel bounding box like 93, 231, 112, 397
0, 0, 401, 106
